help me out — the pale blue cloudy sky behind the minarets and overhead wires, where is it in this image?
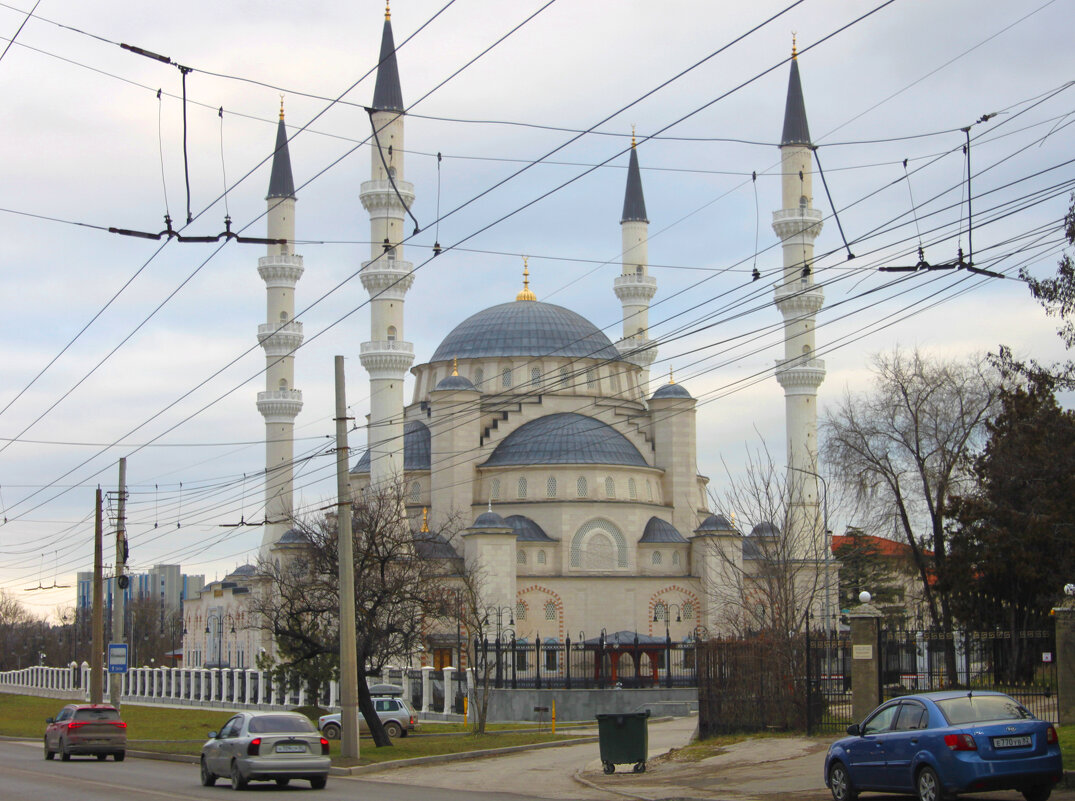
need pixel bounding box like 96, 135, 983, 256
0, 0, 1075, 615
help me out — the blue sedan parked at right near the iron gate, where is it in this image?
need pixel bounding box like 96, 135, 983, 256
825, 690, 1063, 801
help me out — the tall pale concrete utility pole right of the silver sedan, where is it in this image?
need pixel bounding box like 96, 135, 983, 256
335, 356, 358, 759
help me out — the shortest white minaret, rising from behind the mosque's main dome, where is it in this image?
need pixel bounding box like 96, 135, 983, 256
613, 132, 657, 397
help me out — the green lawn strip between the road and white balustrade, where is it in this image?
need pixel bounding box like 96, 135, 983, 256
0, 693, 572, 764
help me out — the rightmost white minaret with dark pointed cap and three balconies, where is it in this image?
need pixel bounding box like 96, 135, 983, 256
773, 41, 825, 556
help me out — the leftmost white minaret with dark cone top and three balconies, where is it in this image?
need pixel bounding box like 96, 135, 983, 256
258, 100, 302, 553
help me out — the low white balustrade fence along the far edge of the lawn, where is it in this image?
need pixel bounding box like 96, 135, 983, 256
0, 662, 474, 714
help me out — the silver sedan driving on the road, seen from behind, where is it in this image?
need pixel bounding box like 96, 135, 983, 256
201, 712, 330, 790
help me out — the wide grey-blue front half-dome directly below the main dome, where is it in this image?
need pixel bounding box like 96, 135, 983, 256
485, 412, 649, 468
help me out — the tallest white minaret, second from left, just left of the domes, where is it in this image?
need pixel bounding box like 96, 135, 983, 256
360, 1, 414, 491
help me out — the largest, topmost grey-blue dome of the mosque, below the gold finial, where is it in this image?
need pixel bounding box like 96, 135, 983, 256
431, 300, 620, 361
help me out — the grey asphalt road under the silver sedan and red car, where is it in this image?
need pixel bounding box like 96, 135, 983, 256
0, 741, 541, 801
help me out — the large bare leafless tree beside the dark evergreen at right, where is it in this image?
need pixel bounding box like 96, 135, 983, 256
821, 348, 1001, 649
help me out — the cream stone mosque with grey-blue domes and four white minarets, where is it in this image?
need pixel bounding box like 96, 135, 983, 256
188, 7, 825, 667
